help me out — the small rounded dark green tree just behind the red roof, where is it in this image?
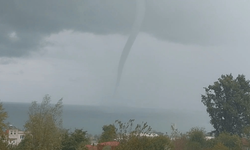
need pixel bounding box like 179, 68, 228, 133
98, 124, 116, 143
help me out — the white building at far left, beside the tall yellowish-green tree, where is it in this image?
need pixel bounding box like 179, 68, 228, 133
7, 125, 24, 145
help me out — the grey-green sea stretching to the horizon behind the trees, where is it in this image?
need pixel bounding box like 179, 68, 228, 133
2, 102, 214, 135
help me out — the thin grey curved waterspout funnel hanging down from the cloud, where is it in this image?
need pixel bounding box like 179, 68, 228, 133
114, 0, 146, 94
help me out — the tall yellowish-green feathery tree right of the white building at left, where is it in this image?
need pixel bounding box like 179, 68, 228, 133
21, 95, 63, 150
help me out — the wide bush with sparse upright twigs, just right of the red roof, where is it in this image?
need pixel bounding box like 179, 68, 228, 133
116, 119, 173, 150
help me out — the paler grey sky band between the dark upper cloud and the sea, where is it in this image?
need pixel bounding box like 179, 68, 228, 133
0, 30, 250, 111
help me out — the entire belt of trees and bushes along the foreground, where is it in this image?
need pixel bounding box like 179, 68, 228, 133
0, 74, 250, 150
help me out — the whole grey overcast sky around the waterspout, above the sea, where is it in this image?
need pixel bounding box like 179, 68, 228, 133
0, 0, 250, 111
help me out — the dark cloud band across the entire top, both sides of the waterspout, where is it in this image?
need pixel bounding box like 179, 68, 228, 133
0, 0, 250, 56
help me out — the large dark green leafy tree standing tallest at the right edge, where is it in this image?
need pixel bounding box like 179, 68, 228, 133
201, 74, 250, 136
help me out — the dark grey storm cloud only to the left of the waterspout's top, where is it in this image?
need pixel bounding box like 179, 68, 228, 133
0, 0, 135, 56
